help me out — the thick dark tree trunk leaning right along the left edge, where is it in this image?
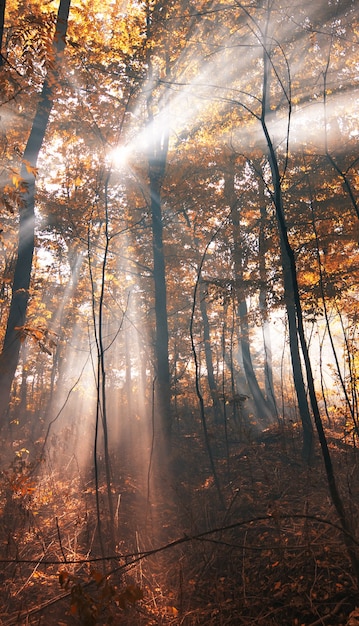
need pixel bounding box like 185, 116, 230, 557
0, 0, 71, 420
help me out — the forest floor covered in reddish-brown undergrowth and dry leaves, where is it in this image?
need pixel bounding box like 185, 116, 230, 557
0, 416, 359, 626
